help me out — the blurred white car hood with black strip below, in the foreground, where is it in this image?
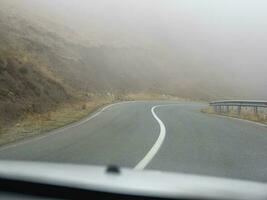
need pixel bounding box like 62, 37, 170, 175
0, 161, 267, 200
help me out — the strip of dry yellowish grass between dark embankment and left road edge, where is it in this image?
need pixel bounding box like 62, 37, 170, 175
0, 97, 114, 145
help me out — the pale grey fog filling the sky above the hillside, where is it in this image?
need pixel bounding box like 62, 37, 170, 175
2, 0, 267, 99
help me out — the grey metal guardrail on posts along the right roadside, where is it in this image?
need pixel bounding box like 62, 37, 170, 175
210, 100, 267, 114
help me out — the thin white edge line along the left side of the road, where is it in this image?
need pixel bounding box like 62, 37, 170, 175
0, 102, 128, 152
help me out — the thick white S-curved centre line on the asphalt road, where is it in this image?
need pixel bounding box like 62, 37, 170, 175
134, 105, 167, 170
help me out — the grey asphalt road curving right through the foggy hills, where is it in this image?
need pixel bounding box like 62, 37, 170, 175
0, 101, 267, 181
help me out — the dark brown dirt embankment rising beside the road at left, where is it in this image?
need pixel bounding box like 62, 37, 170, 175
0, 53, 71, 128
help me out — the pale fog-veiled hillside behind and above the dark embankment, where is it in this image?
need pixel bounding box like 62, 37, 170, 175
0, 1, 253, 100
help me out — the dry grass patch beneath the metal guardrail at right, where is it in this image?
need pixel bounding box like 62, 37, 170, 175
201, 107, 267, 124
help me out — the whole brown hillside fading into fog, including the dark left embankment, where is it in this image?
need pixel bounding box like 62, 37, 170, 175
0, 0, 264, 131
